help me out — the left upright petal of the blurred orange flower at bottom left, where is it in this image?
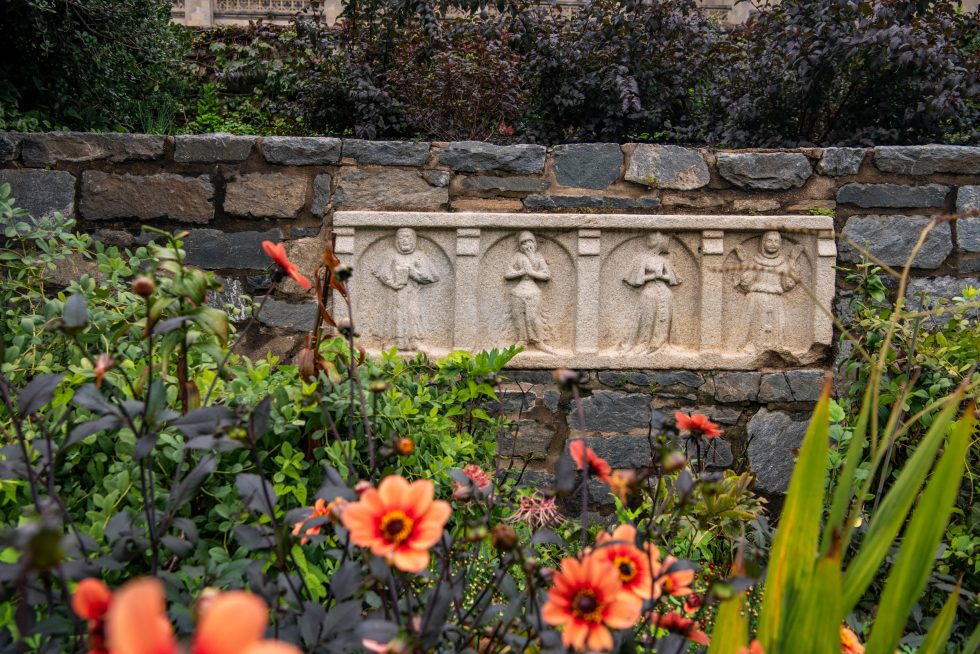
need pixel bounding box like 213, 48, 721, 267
106, 578, 177, 654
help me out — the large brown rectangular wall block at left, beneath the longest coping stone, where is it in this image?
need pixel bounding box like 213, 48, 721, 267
78, 170, 214, 223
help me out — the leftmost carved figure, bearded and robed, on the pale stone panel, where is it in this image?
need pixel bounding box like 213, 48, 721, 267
374, 227, 439, 351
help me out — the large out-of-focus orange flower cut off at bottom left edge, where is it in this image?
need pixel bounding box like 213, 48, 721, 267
106, 578, 301, 654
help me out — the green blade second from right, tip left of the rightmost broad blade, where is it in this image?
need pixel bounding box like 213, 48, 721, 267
844, 392, 962, 615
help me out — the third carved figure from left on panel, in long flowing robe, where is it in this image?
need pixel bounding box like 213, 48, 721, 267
620, 232, 680, 354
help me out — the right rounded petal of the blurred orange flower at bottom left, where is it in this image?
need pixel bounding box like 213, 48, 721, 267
191, 590, 269, 654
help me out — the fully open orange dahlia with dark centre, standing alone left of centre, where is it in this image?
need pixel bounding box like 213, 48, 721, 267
341, 475, 452, 572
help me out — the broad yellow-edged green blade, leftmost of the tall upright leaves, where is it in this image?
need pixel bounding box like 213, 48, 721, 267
759, 380, 830, 654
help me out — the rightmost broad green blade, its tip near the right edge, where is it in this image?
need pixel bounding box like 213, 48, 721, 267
865, 403, 976, 654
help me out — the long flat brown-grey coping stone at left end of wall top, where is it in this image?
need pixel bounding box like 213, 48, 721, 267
20, 132, 166, 167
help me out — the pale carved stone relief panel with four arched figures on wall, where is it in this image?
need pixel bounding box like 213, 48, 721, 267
334, 211, 837, 370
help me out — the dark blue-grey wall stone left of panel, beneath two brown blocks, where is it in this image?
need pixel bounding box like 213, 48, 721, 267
184, 228, 282, 270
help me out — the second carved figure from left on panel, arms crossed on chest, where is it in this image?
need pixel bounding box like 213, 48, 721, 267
504, 231, 554, 354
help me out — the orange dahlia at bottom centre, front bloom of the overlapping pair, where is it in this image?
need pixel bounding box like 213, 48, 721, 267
541, 554, 643, 651
